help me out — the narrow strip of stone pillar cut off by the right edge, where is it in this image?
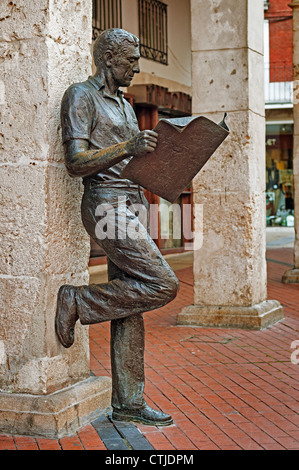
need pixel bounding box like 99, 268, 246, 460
282, 0, 299, 283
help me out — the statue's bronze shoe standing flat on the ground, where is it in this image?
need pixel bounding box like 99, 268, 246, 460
112, 404, 173, 426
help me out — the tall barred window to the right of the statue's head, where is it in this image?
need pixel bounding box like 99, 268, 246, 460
138, 0, 168, 65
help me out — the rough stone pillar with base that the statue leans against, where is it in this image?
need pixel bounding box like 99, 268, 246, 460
0, 0, 111, 438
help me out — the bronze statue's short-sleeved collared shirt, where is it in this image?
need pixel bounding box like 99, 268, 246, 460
61, 77, 139, 182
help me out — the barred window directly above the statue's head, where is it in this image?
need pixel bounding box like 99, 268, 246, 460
92, 0, 122, 39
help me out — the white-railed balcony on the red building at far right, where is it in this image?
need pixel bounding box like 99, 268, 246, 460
265, 63, 293, 108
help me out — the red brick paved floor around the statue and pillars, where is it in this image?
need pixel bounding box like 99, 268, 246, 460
0, 248, 299, 450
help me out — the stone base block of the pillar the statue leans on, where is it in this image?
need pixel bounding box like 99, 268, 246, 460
0, 377, 111, 439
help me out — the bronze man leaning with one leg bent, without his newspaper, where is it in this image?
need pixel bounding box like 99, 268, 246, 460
55, 29, 179, 425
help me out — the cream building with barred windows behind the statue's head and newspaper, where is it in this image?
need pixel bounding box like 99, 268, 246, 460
91, 0, 193, 263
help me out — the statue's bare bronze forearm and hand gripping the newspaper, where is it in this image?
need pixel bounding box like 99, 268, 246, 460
64, 130, 157, 177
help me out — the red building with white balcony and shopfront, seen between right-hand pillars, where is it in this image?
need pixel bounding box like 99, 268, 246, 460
264, 0, 294, 226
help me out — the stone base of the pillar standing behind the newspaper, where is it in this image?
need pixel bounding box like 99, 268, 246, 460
177, 300, 284, 330
